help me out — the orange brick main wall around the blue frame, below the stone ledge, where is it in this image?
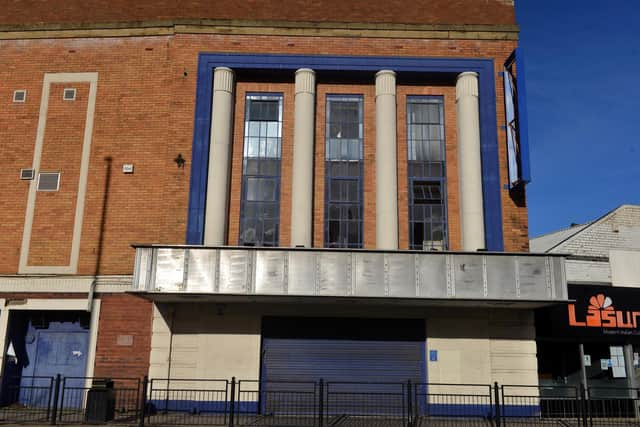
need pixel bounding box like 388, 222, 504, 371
0, 35, 528, 274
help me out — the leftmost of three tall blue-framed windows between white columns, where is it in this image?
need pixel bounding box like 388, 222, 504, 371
239, 94, 282, 246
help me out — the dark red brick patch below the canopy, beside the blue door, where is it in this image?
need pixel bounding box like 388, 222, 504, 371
94, 294, 153, 378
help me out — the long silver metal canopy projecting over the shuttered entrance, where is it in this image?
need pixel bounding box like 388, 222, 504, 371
132, 245, 567, 306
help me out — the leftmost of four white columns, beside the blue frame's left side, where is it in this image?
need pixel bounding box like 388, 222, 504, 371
204, 67, 234, 245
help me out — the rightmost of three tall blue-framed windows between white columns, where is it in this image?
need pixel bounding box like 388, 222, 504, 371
407, 96, 448, 249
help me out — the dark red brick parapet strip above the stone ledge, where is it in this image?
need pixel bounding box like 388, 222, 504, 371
0, 0, 515, 25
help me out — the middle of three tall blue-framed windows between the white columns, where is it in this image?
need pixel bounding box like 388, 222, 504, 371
324, 95, 364, 248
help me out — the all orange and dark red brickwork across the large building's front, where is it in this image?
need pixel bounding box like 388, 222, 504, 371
0, 0, 528, 377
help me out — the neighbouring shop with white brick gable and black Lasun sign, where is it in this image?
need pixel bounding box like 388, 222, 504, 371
531, 205, 640, 397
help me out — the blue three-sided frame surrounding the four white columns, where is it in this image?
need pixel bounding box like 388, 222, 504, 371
187, 53, 504, 251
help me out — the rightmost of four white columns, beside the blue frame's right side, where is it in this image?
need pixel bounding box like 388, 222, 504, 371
456, 72, 485, 251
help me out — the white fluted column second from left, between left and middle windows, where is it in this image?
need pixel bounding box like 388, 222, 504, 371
291, 68, 316, 248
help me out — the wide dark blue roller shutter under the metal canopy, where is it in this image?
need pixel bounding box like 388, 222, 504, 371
262, 318, 426, 383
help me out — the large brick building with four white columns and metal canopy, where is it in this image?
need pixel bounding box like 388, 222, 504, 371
0, 0, 567, 404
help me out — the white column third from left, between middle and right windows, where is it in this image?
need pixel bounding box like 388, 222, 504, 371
376, 70, 398, 250
